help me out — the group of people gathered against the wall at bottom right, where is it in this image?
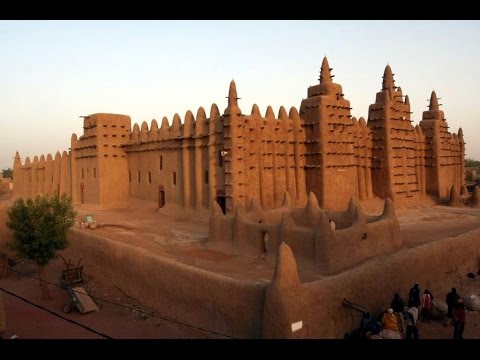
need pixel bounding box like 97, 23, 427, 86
360, 283, 465, 339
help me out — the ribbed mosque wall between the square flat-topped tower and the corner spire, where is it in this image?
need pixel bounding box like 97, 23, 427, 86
127, 105, 218, 209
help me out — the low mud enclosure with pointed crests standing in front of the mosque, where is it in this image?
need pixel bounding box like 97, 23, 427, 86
207, 192, 403, 274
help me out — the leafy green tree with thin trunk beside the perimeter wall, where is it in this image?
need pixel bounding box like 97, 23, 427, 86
7, 194, 76, 299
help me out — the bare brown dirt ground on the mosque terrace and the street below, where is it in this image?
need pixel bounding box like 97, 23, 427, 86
0, 196, 480, 339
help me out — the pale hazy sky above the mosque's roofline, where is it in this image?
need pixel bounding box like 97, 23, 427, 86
0, 21, 480, 169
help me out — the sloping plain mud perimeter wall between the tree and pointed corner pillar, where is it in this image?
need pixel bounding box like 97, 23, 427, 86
62, 229, 267, 338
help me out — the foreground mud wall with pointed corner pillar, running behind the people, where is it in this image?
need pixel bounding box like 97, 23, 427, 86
263, 230, 480, 338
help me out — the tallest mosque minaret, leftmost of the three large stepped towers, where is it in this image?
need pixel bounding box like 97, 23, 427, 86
300, 57, 358, 210
